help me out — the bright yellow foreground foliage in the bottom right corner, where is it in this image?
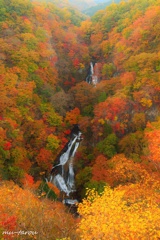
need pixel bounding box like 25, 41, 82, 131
77, 180, 160, 240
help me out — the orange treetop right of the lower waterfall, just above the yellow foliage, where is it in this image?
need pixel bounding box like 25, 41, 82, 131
92, 154, 147, 187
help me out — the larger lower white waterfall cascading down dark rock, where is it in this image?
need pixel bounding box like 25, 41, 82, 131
49, 125, 82, 204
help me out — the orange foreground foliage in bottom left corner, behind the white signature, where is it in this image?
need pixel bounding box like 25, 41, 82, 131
0, 182, 76, 240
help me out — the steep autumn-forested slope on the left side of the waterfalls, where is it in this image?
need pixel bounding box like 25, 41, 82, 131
0, 0, 87, 182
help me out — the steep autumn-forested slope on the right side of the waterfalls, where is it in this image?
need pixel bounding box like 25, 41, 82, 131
70, 0, 160, 199
